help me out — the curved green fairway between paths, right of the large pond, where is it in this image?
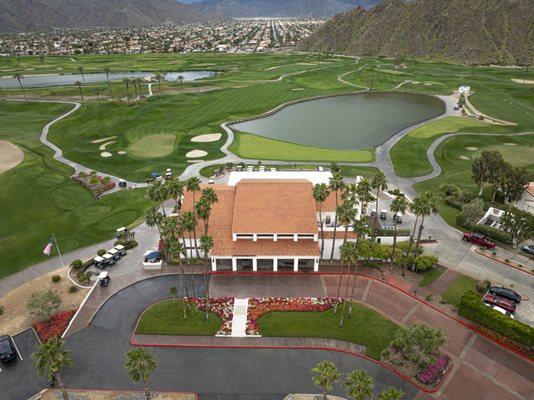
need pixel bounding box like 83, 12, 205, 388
390, 117, 506, 178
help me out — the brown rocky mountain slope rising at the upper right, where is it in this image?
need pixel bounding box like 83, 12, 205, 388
299, 0, 534, 64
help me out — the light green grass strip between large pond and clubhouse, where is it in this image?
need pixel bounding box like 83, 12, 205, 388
230, 133, 374, 162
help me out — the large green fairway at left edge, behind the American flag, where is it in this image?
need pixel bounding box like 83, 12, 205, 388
0, 102, 149, 278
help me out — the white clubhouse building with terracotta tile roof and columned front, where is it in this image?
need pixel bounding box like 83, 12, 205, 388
181, 171, 361, 271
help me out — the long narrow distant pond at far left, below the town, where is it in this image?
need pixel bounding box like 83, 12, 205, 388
0, 71, 215, 89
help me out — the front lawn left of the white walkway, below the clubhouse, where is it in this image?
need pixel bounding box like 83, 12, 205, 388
135, 299, 221, 336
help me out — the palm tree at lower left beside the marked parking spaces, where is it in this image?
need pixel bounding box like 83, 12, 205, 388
32, 337, 74, 400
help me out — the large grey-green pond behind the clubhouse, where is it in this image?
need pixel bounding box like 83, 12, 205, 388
232, 92, 445, 149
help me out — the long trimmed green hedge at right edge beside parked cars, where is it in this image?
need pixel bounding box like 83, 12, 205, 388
458, 290, 534, 349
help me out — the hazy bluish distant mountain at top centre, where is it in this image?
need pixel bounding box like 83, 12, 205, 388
195, 0, 380, 18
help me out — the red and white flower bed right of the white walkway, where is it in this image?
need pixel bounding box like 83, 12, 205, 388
246, 297, 336, 335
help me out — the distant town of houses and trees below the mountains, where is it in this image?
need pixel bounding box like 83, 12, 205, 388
0, 18, 323, 56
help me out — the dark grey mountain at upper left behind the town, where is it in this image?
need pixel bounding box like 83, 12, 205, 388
0, 0, 202, 32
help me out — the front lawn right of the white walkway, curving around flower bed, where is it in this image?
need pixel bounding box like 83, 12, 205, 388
258, 303, 398, 359
